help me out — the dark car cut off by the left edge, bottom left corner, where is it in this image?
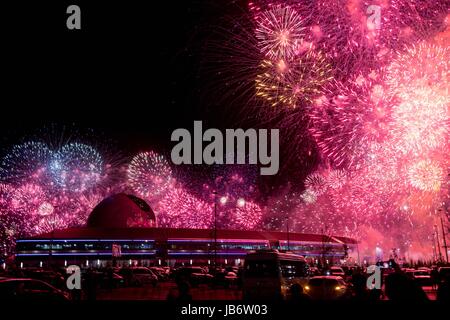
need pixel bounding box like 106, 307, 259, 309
0, 278, 70, 301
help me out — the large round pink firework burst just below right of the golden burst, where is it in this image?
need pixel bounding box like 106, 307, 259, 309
309, 77, 396, 169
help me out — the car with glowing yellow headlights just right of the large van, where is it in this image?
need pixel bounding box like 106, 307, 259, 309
304, 276, 351, 300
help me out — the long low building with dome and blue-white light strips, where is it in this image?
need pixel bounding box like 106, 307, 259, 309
16, 193, 357, 267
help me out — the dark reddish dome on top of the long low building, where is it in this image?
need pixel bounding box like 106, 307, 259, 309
87, 193, 156, 228
